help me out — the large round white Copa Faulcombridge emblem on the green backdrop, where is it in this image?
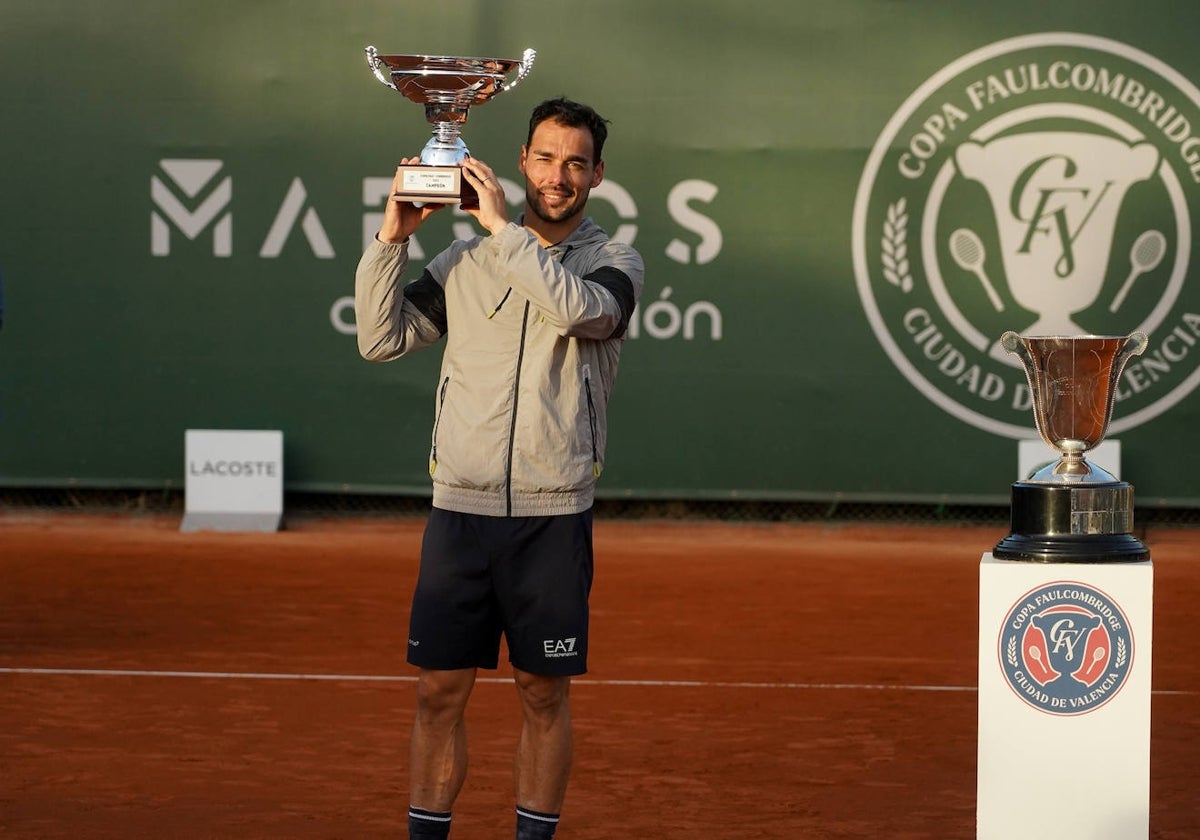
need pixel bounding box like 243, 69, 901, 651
853, 32, 1200, 438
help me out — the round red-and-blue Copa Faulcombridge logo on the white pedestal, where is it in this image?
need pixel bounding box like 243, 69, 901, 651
1000, 581, 1133, 715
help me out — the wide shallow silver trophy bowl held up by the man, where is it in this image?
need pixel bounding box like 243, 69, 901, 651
366, 47, 536, 205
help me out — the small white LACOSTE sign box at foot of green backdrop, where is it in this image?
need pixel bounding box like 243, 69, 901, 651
179, 428, 283, 532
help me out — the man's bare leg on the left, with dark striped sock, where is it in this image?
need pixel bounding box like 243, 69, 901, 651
408, 668, 475, 838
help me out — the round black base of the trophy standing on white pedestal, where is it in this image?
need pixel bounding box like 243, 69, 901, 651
992, 481, 1150, 563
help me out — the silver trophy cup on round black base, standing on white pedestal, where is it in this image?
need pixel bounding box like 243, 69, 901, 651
992, 331, 1150, 563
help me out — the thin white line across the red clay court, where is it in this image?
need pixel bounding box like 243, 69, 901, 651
0, 668, 1196, 695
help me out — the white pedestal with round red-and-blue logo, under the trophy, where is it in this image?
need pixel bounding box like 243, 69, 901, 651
976, 552, 1154, 840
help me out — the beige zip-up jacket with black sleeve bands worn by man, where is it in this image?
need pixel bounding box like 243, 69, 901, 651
354, 218, 644, 516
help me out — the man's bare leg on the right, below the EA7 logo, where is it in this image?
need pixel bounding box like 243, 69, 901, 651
514, 668, 572, 840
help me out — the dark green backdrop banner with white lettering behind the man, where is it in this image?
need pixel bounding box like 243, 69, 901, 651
0, 0, 1200, 504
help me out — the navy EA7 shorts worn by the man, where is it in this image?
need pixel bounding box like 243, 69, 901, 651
408, 508, 593, 677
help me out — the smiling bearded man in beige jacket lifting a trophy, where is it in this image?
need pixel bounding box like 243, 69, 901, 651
355, 98, 643, 840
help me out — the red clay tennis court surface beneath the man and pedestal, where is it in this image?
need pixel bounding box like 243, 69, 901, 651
0, 511, 1200, 840
